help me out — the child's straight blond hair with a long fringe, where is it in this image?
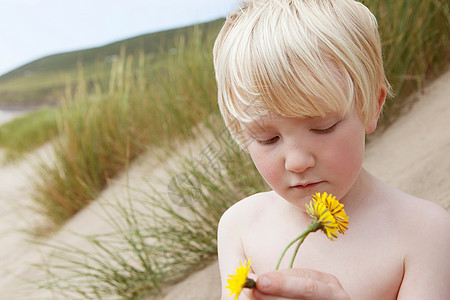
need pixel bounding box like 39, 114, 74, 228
214, 0, 390, 144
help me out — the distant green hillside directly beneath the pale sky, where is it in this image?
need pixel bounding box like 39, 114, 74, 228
0, 19, 224, 108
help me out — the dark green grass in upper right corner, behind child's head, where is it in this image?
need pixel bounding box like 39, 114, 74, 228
362, 0, 450, 124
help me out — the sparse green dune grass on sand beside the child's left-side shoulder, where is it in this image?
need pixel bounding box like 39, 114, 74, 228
34, 115, 267, 299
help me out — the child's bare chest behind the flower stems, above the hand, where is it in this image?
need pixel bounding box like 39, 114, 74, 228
243, 220, 403, 299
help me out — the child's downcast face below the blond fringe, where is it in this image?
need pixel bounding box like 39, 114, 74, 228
242, 108, 366, 208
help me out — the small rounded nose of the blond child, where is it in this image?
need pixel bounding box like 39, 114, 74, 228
284, 143, 316, 173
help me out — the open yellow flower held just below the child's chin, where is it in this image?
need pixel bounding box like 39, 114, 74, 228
306, 193, 348, 240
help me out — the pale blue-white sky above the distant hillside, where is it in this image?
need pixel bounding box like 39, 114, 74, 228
0, 0, 239, 76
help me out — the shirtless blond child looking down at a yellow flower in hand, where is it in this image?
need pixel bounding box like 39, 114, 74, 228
214, 0, 450, 300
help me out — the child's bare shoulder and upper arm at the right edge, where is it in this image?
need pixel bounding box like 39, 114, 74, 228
378, 183, 450, 299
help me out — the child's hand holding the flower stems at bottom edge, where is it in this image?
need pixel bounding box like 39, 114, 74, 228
253, 269, 350, 300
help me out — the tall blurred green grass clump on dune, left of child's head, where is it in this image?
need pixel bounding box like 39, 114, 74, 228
34, 30, 217, 225
